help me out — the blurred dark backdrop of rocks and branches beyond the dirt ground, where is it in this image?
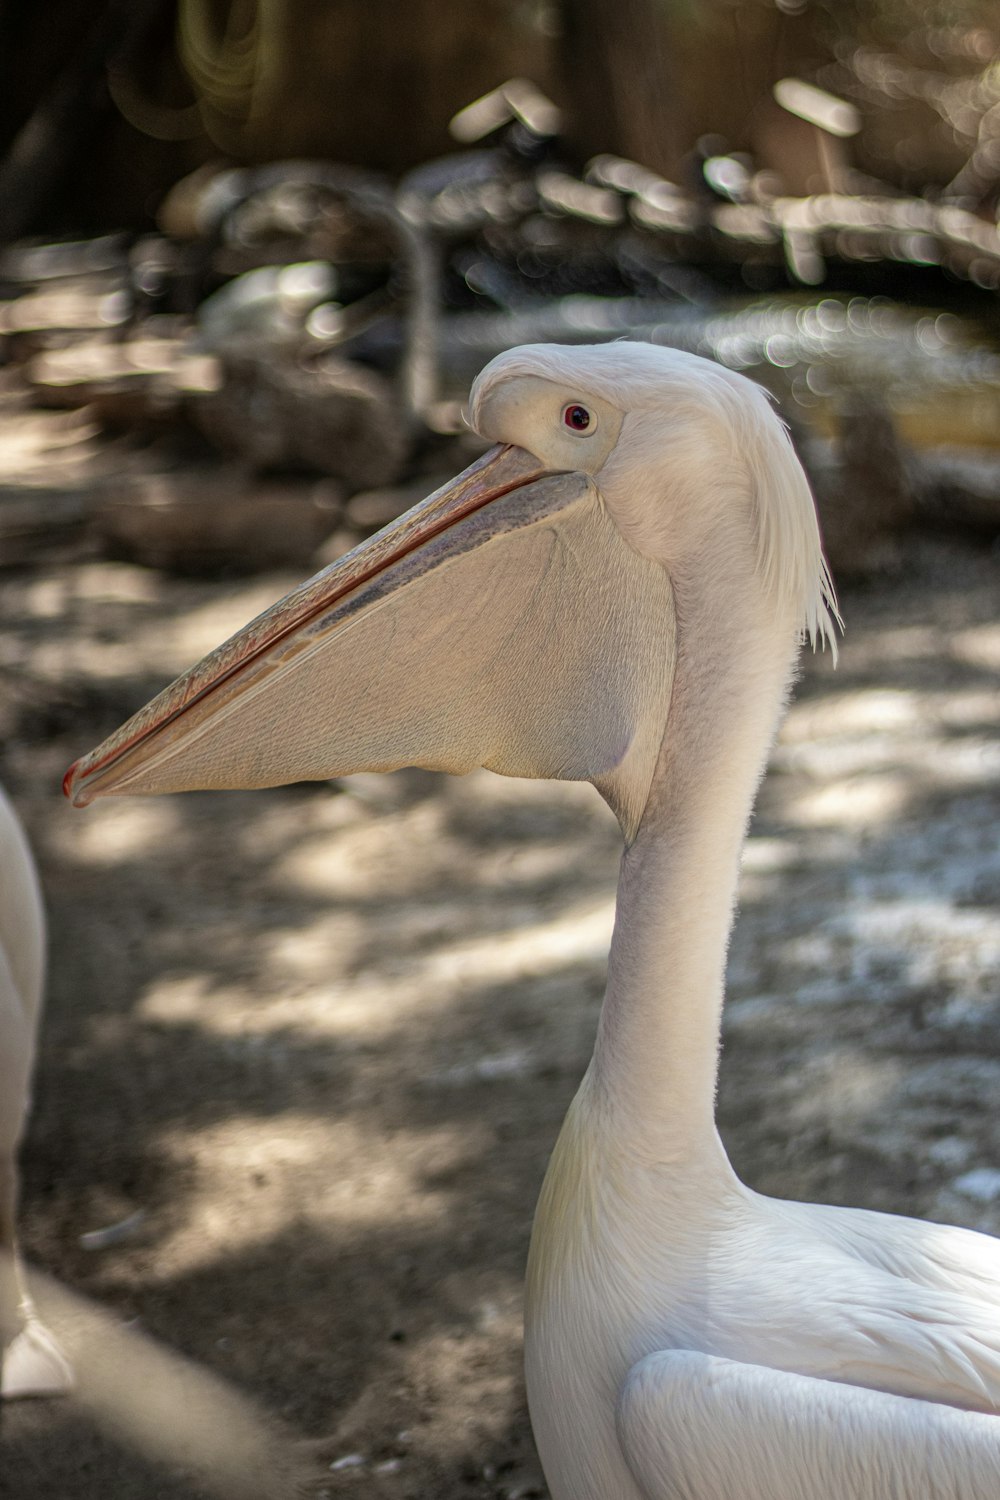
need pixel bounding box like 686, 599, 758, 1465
0, 0, 1000, 576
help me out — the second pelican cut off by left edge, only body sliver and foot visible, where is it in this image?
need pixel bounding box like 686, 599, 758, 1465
0, 791, 72, 1401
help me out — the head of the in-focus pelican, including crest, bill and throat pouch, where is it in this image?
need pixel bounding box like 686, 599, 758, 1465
58, 344, 834, 837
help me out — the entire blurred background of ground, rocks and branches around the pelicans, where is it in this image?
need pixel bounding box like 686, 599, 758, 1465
0, 0, 1000, 1500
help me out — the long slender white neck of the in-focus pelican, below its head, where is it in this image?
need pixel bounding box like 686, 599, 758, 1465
591, 558, 795, 1166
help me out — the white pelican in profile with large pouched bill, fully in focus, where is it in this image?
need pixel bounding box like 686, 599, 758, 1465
66, 344, 1000, 1500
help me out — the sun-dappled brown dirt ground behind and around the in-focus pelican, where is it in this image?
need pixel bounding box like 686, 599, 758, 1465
0, 414, 1000, 1500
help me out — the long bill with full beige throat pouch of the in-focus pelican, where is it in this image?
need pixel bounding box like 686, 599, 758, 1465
64, 429, 673, 834
